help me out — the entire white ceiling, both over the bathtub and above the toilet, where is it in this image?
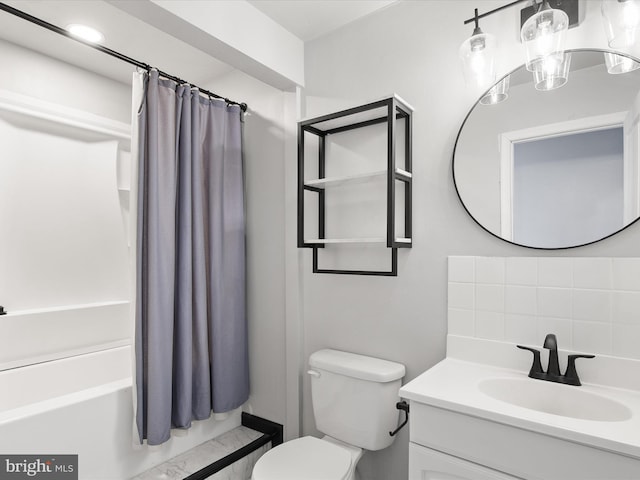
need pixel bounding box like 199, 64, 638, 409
0, 0, 397, 85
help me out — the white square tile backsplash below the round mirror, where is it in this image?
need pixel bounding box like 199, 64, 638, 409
448, 256, 640, 359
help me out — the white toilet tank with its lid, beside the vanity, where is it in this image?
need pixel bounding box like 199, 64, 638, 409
309, 349, 405, 450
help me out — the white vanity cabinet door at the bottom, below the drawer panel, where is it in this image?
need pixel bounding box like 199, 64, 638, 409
409, 443, 518, 480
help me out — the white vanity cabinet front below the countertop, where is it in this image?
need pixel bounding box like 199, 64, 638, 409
409, 401, 640, 480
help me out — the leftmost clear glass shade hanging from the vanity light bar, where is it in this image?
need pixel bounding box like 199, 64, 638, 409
459, 29, 496, 89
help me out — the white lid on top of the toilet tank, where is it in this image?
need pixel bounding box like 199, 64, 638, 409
309, 349, 405, 383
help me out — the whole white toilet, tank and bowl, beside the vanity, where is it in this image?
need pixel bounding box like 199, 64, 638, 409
251, 349, 405, 480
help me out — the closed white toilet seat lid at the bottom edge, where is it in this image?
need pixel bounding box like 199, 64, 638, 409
251, 436, 351, 480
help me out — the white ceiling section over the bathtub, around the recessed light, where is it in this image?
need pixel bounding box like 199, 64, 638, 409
0, 0, 231, 84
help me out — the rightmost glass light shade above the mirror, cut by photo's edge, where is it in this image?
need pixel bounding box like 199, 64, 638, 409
602, 0, 640, 48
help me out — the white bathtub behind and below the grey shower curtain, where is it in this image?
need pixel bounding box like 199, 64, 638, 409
0, 346, 241, 480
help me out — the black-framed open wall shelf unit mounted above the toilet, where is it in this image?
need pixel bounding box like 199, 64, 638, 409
297, 95, 413, 276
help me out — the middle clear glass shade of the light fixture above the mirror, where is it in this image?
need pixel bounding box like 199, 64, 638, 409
520, 2, 569, 72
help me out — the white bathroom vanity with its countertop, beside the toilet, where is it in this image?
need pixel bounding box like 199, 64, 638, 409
400, 359, 640, 480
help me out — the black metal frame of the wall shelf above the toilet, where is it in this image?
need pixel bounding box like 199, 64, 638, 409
297, 95, 413, 276
